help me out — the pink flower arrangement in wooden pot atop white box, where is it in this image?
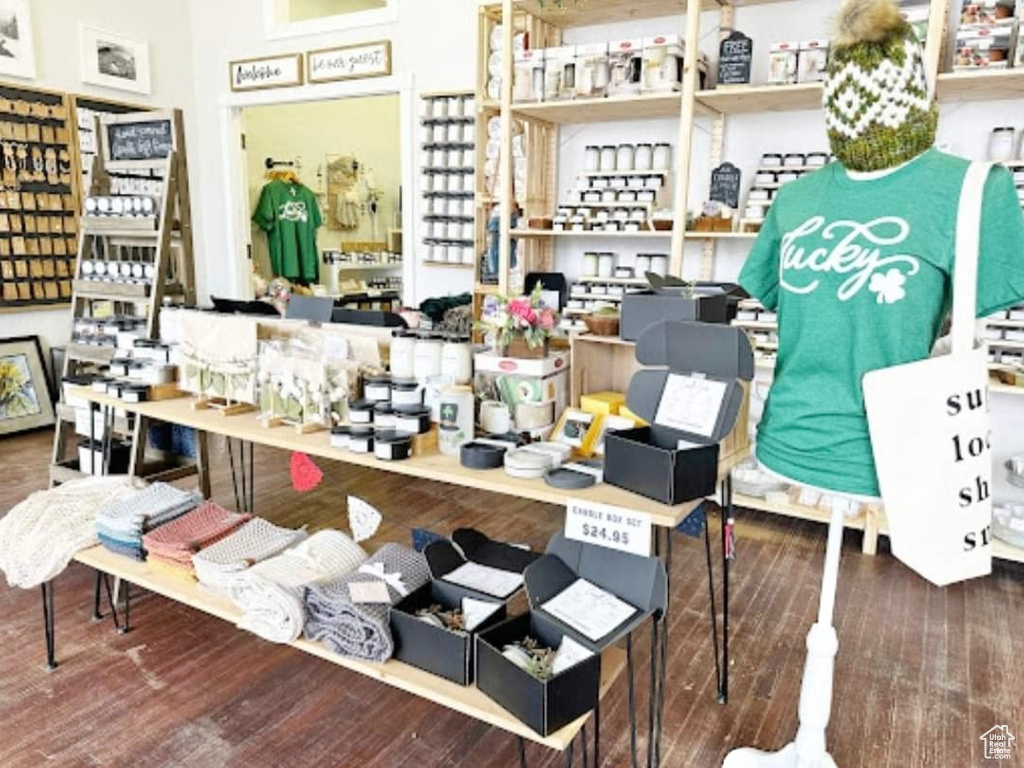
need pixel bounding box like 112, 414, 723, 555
476, 283, 559, 358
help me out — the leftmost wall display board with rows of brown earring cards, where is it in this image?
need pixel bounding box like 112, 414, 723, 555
0, 83, 79, 309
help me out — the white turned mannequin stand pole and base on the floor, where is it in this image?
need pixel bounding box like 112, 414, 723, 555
723, 501, 846, 768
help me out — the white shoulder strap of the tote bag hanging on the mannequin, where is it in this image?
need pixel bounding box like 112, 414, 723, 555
950, 162, 992, 354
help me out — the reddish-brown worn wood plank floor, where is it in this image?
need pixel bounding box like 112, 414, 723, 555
0, 433, 1024, 768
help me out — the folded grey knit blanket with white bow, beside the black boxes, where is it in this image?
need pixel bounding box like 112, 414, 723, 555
303, 544, 430, 664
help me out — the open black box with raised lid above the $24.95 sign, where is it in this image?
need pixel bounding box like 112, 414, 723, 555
604, 321, 754, 505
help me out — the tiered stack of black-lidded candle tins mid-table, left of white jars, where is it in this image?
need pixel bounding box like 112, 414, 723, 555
331, 375, 431, 461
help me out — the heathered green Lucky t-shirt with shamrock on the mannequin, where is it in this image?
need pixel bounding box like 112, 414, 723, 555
739, 150, 1024, 497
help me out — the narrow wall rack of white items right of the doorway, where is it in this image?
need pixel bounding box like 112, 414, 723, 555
422, 93, 476, 264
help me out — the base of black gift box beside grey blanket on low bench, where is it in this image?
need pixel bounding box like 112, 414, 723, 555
391, 582, 506, 685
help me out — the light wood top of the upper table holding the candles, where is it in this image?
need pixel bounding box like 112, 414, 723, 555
72, 385, 745, 527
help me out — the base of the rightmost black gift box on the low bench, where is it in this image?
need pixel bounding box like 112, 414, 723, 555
476, 611, 601, 736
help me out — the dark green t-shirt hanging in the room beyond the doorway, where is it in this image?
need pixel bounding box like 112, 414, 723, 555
253, 180, 323, 283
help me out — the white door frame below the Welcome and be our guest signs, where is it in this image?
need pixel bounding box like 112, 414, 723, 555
220, 74, 417, 305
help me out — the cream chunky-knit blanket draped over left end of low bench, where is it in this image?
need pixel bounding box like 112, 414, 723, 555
0, 475, 142, 589
